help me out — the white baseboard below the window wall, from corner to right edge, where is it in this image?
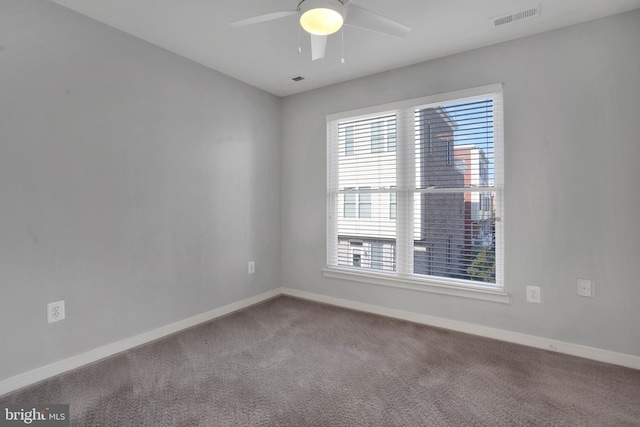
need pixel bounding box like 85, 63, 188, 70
280, 288, 640, 369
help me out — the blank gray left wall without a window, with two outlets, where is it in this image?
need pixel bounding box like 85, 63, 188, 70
0, 0, 281, 380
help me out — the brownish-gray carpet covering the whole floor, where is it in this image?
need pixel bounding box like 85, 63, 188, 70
0, 297, 640, 426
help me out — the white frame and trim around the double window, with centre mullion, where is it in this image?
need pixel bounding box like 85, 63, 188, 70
322, 84, 510, 304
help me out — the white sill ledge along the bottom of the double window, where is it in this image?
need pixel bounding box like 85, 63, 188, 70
322, 267, 510, 304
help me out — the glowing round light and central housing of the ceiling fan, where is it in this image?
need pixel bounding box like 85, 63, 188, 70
298, 0, 345, 36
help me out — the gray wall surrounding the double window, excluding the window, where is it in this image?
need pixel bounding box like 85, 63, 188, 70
281, 10, 640, 356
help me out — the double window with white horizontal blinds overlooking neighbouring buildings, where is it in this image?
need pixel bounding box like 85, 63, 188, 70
327, 85, 508, 300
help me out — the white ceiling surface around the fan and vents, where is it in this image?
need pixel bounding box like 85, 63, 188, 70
52, 0, 640, 96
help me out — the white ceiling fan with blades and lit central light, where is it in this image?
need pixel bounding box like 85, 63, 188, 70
230, 0, 411, 61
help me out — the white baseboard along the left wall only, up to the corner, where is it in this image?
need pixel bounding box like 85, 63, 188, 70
0, 288, 282, 395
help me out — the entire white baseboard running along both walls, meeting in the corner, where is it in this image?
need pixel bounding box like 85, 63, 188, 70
0, 288, 640, 395
